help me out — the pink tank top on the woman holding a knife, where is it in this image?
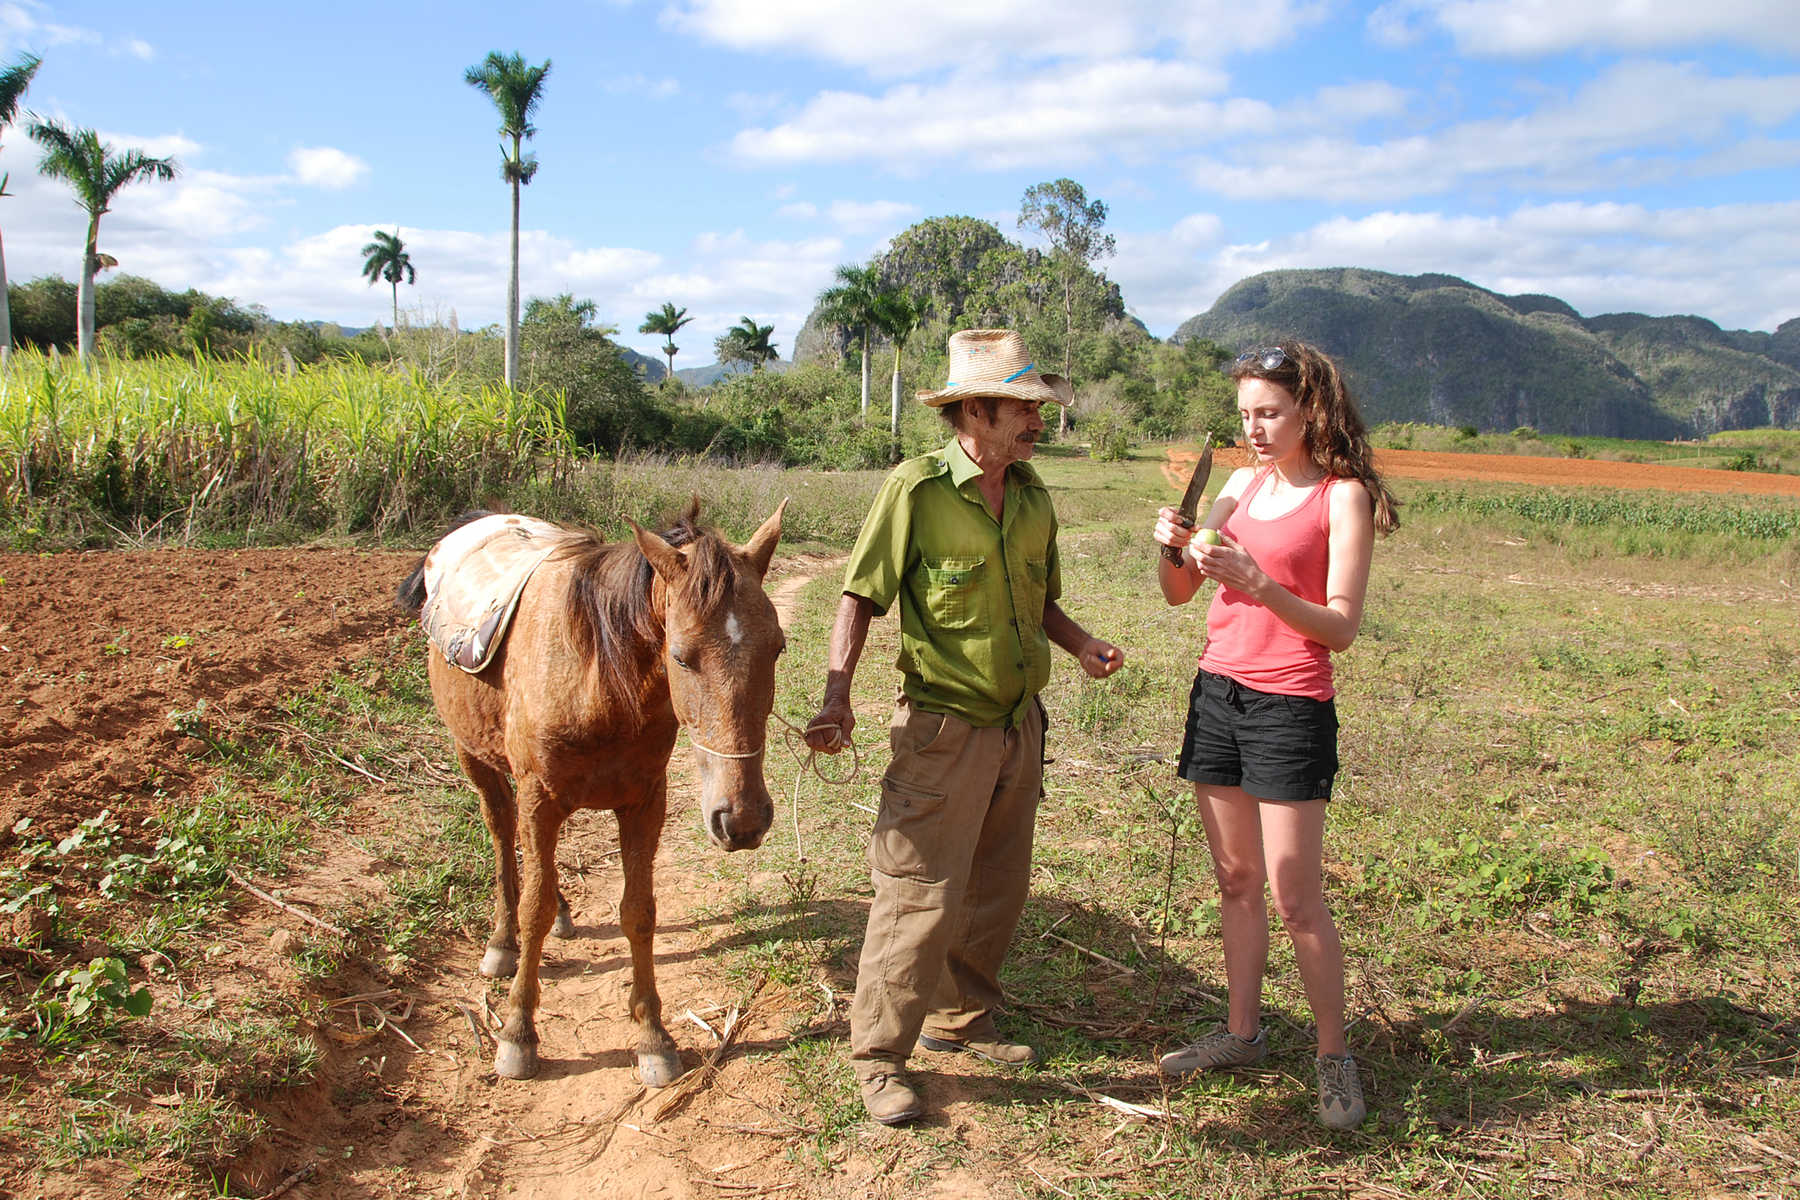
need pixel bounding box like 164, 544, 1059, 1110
1201, 470, 1337, 700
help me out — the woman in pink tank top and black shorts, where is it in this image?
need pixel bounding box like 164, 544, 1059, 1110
1156, 342, 1399, 1130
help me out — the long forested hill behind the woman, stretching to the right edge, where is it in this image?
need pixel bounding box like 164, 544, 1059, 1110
1174, 268, 1800, 439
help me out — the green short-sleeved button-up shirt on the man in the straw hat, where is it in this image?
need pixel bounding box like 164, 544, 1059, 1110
844, 437, 1062, 727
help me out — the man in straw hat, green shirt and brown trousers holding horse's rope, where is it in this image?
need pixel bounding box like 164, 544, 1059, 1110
806, 329, 1125, 1124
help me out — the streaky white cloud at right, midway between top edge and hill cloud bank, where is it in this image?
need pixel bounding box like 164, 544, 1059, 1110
1190, 61, 1800, 201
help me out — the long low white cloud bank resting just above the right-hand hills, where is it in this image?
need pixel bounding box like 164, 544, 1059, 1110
1109, 201, 1800, 335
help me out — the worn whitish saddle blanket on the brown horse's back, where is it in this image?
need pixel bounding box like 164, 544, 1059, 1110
419, 513, 569, 675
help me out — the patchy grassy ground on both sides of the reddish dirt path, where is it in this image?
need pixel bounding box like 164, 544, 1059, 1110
0, 453, 1800, 1198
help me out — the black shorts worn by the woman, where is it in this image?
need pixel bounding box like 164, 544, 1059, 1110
1179, 671, 1337, 801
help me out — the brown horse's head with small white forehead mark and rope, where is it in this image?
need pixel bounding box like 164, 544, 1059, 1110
634, 500, 787, 849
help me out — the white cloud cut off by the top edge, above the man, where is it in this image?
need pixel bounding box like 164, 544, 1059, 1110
662, 0, 1325, 77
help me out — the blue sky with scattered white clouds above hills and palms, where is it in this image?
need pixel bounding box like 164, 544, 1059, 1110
0, 0, 1800, 367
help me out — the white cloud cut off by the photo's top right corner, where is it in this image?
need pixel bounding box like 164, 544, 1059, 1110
1368, 0, 1800, 58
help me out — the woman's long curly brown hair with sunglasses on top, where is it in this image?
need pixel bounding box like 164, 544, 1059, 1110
1228, 338, 1400, 534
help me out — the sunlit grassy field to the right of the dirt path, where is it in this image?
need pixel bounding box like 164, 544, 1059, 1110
720, 459, 1800, 1196
